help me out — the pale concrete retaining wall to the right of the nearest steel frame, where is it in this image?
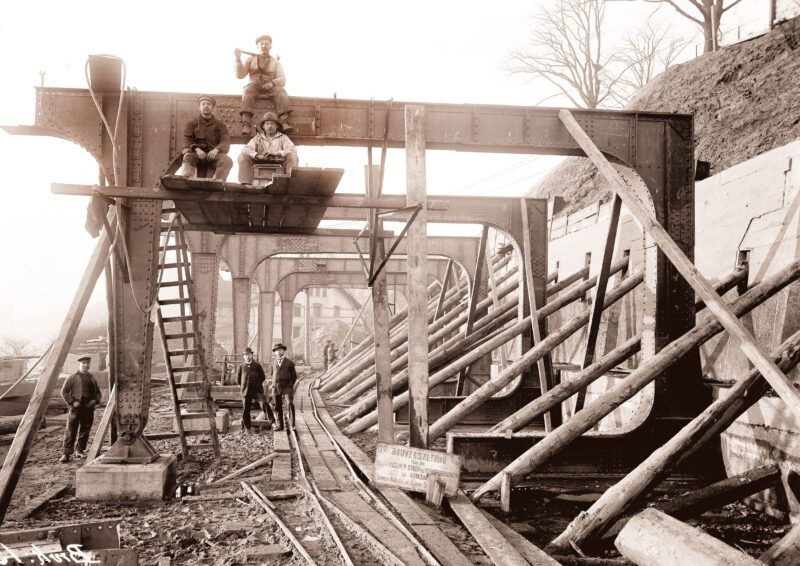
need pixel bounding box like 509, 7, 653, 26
695, 141, 800, 516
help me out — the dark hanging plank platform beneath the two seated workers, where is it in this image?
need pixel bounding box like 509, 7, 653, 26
161, 167, 344, 233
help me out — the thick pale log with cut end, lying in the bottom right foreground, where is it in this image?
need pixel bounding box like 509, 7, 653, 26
614, 509, 764, 566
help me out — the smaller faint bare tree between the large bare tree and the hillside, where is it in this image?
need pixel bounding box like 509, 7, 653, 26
619, 22, 689, 94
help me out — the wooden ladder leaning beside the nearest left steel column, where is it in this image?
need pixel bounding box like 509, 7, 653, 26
156, 208, 220, 462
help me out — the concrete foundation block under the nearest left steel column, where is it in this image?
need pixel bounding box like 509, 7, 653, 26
75, 454, 178, 501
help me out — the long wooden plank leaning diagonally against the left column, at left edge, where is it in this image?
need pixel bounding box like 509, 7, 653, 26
0, 217, 116, 523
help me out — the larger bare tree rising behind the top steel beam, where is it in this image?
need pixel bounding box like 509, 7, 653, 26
508, 0, 628, 108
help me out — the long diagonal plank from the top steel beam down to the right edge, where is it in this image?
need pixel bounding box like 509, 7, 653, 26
558, 109, 800, 426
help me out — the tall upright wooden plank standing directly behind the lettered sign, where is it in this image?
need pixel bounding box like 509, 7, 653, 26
405, 105, 428, 448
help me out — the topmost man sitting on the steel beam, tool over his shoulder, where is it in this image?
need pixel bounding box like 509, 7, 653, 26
233, 35, 293, 136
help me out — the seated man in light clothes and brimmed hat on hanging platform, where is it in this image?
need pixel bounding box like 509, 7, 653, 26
239, 112, 298, 185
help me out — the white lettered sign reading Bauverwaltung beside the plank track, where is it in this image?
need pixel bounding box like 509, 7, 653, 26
374, 443, 461, 495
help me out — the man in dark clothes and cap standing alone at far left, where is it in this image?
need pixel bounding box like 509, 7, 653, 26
60, 356, 103, 464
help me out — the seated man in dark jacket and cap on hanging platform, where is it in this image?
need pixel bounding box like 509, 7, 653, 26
178, 94, 233, 181
